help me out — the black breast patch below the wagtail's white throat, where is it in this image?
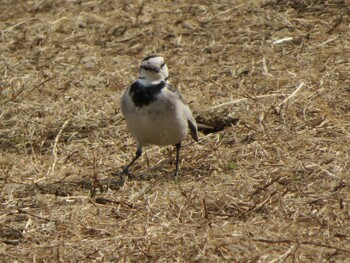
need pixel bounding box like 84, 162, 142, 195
129, 81, 166, 107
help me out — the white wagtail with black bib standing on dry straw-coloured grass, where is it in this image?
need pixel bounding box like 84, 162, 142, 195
121, 55, 198, 176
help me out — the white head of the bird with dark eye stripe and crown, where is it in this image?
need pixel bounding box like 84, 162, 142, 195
140, 55, 169, 82
